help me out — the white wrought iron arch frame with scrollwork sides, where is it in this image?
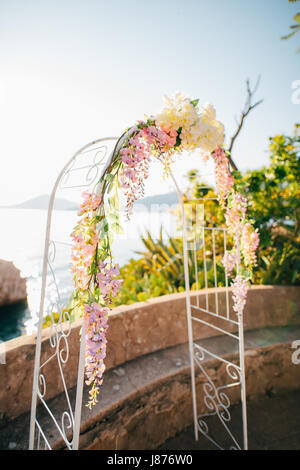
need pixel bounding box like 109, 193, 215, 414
29, 134, 248, 450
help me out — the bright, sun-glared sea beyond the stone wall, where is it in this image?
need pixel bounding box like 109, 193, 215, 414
0, 206, 178, 342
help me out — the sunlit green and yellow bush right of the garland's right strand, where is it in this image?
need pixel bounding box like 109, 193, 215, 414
243, 125, 300, 285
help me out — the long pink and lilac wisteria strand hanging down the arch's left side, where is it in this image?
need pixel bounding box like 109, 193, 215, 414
71, 192, 122, 407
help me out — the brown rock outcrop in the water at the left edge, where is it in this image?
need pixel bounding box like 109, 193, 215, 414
0, 260, 27, 306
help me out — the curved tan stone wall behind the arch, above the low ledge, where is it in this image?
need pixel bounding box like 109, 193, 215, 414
0, 286, 300, 424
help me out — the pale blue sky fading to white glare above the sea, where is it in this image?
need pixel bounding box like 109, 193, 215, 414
0, 0, 300, 205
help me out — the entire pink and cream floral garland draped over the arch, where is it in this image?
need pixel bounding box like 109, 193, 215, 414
69, 93, 259, 408
